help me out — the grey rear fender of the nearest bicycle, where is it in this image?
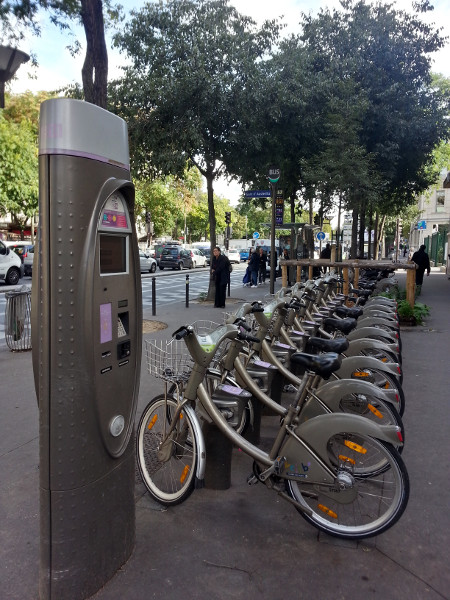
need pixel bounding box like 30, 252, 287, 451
295, 413, 401, 468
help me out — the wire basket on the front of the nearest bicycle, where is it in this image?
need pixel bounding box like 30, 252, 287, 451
145, 340, 193, 383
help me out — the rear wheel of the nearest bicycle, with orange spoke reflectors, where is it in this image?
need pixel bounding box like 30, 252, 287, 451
286, 433, 409, 540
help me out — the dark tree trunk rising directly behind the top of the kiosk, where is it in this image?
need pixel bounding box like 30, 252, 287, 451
80, 0, 108, 109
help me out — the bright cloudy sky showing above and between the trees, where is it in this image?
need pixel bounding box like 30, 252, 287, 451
7, 0, 450, 204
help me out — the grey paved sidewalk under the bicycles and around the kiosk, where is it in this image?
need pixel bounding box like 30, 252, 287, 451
0, 269, 450, 600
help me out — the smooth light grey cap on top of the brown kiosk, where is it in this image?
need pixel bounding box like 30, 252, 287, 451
39, 98, 130, 170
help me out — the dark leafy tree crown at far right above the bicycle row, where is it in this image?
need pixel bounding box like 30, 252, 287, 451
296, 0, 449, 254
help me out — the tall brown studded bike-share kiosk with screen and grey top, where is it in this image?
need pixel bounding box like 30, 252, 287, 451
32, 99, 142, 600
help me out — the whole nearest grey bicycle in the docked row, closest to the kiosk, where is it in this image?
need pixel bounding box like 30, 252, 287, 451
137, 325, 409, 539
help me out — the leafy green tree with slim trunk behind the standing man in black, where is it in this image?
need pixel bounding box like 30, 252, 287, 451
116, 0, 278, 296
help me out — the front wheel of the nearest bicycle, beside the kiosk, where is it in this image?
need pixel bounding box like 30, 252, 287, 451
136, 394, 198, 506
